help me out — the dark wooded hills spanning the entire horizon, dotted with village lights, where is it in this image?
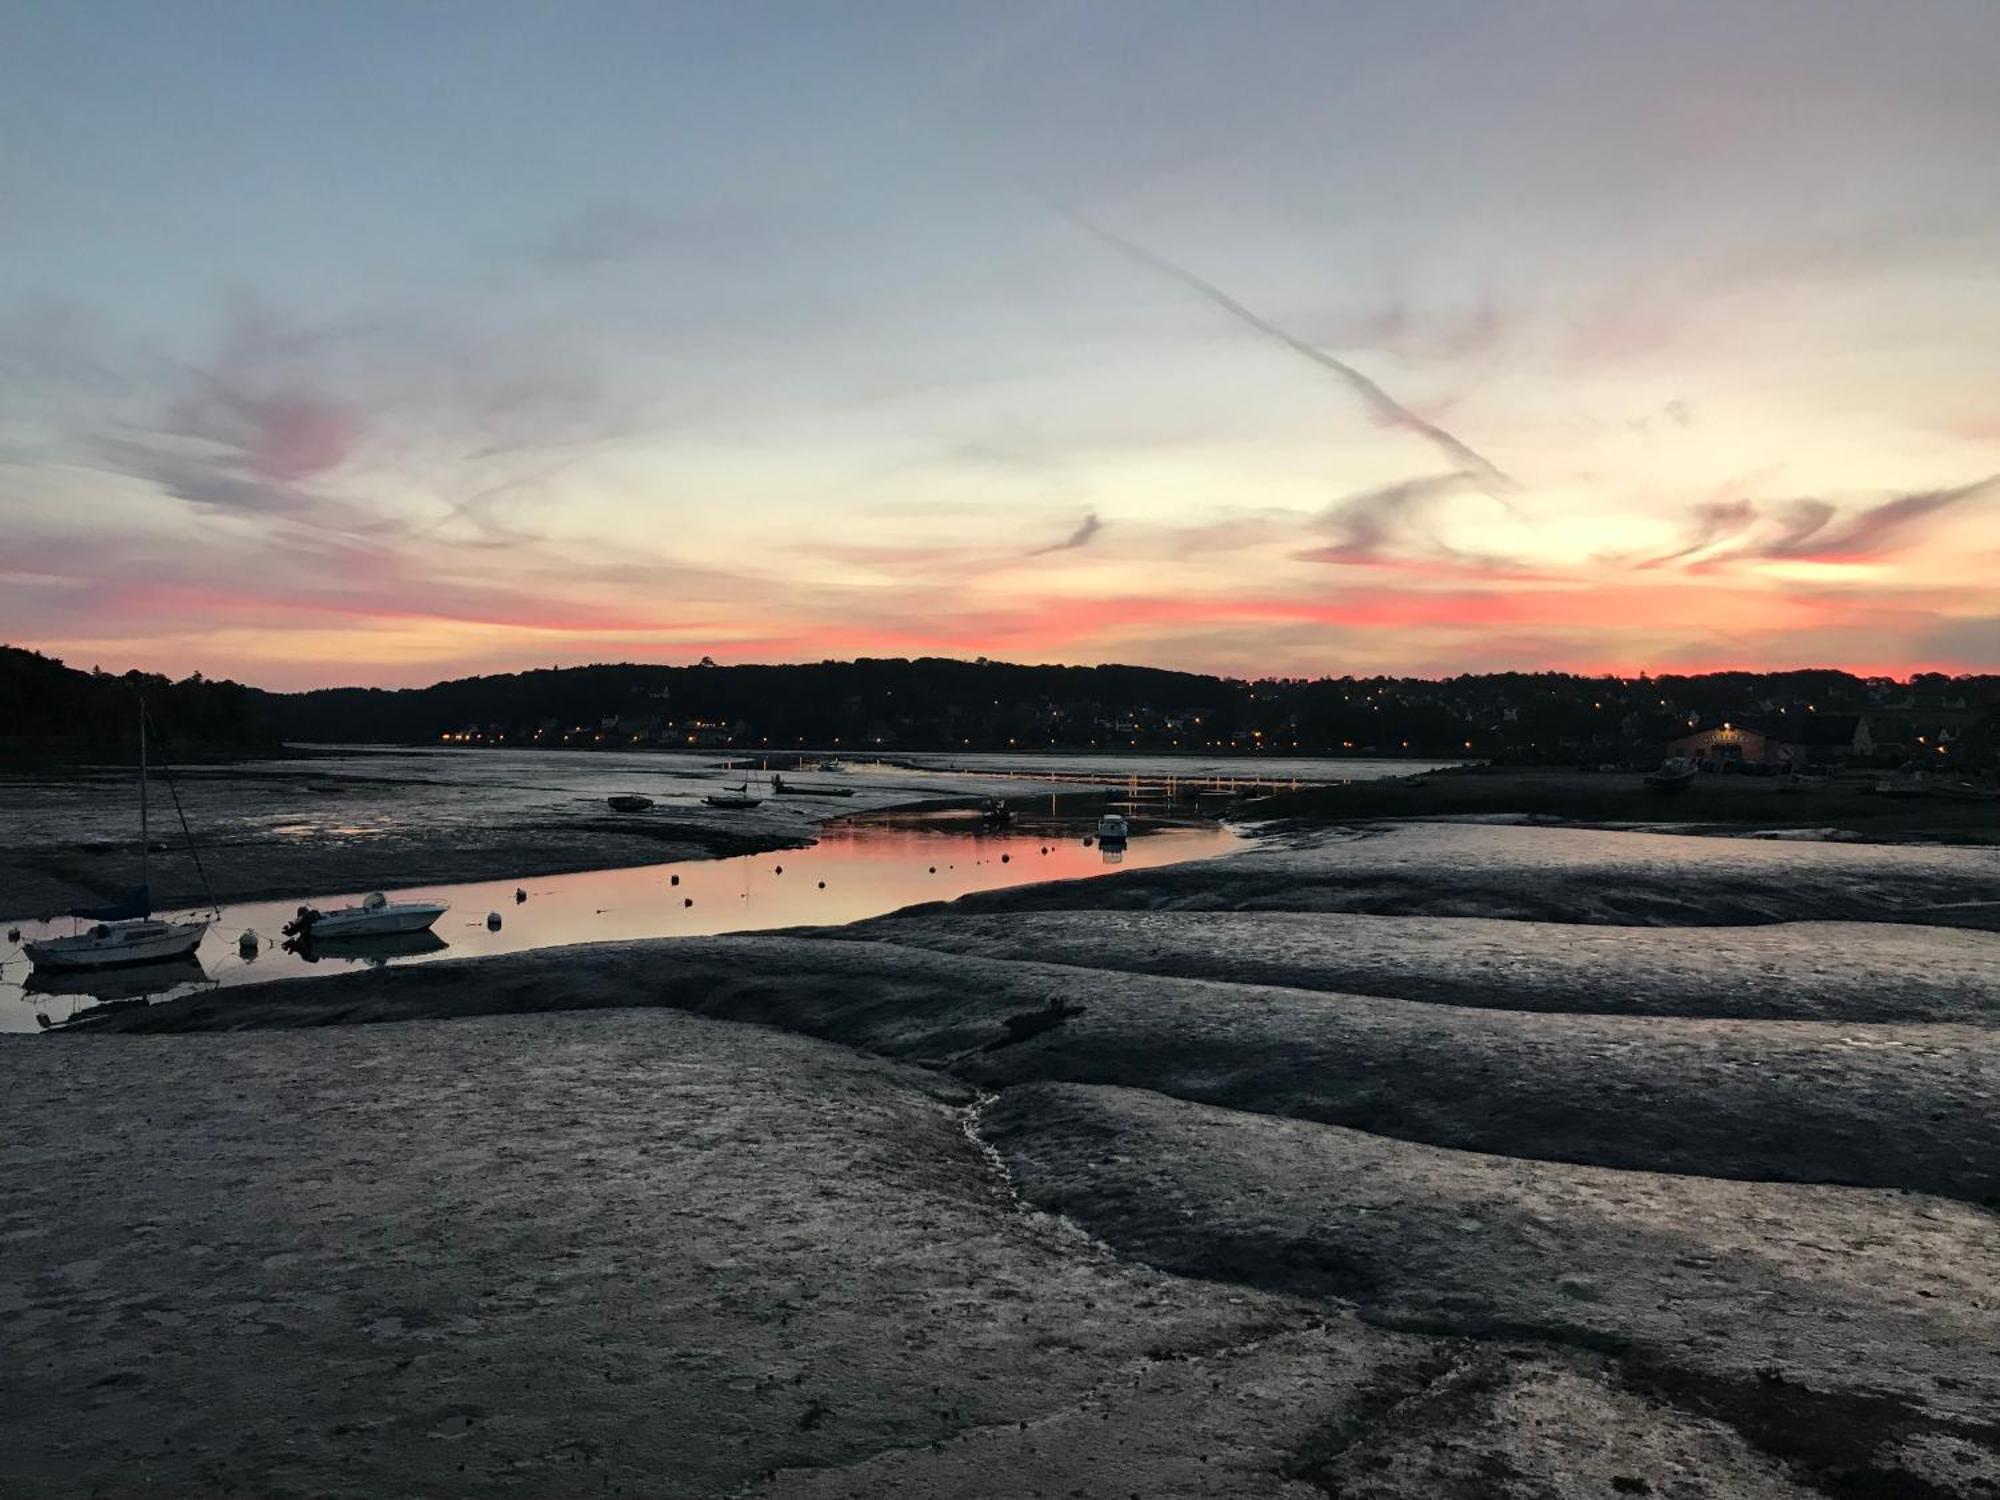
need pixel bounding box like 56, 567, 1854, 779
0, 648, 2000, 766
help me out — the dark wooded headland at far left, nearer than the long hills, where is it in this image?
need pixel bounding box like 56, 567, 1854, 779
0, 646, 282, 756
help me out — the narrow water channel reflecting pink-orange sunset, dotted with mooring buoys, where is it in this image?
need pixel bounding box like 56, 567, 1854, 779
0, 814, 1242, 1032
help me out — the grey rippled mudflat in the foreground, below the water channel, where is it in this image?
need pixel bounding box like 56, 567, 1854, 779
0, 826, 2000, 1500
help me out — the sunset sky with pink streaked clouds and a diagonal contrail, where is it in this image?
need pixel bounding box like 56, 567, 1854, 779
0, 0, 2000, 688
